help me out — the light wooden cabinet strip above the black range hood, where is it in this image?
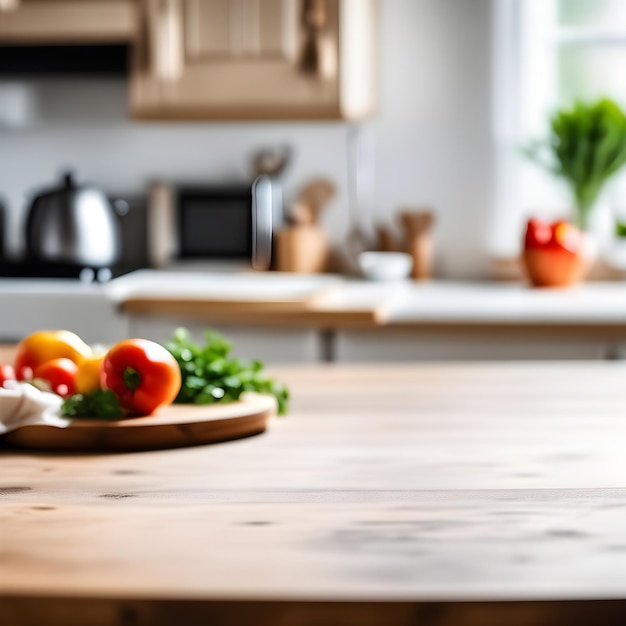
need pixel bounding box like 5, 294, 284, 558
0, 0, 138, 44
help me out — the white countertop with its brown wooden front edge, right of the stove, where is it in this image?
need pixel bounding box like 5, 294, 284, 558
114, 271, 626, 327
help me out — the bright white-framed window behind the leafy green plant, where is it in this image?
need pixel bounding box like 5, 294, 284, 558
489, 0, 626, 256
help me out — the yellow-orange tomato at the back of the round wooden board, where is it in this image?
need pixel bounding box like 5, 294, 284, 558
15, 330, 91, 380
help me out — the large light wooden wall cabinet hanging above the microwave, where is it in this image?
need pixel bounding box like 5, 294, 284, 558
131, 0, 377, 120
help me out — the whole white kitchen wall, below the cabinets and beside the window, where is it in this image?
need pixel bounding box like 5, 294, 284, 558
0, 0, 492, 277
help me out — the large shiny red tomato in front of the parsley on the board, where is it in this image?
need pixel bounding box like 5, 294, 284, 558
100, 339, 181, 415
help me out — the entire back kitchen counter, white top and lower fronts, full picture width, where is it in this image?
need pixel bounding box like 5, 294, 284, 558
0, 269, 626, 362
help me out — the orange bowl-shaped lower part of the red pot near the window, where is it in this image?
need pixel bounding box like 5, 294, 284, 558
522, 250, 589, 287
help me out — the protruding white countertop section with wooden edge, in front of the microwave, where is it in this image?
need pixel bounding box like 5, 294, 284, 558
111, 270, 390, 327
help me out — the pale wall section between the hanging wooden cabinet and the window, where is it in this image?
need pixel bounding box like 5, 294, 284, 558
374, 0, 492, 277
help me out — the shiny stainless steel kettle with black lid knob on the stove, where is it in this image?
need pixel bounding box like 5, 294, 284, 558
26, 174, 121, 267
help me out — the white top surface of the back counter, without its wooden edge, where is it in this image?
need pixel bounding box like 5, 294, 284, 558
102, 270, 626, 324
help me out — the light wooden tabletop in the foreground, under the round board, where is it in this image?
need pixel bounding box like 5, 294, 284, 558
0, 362, 626, 626
